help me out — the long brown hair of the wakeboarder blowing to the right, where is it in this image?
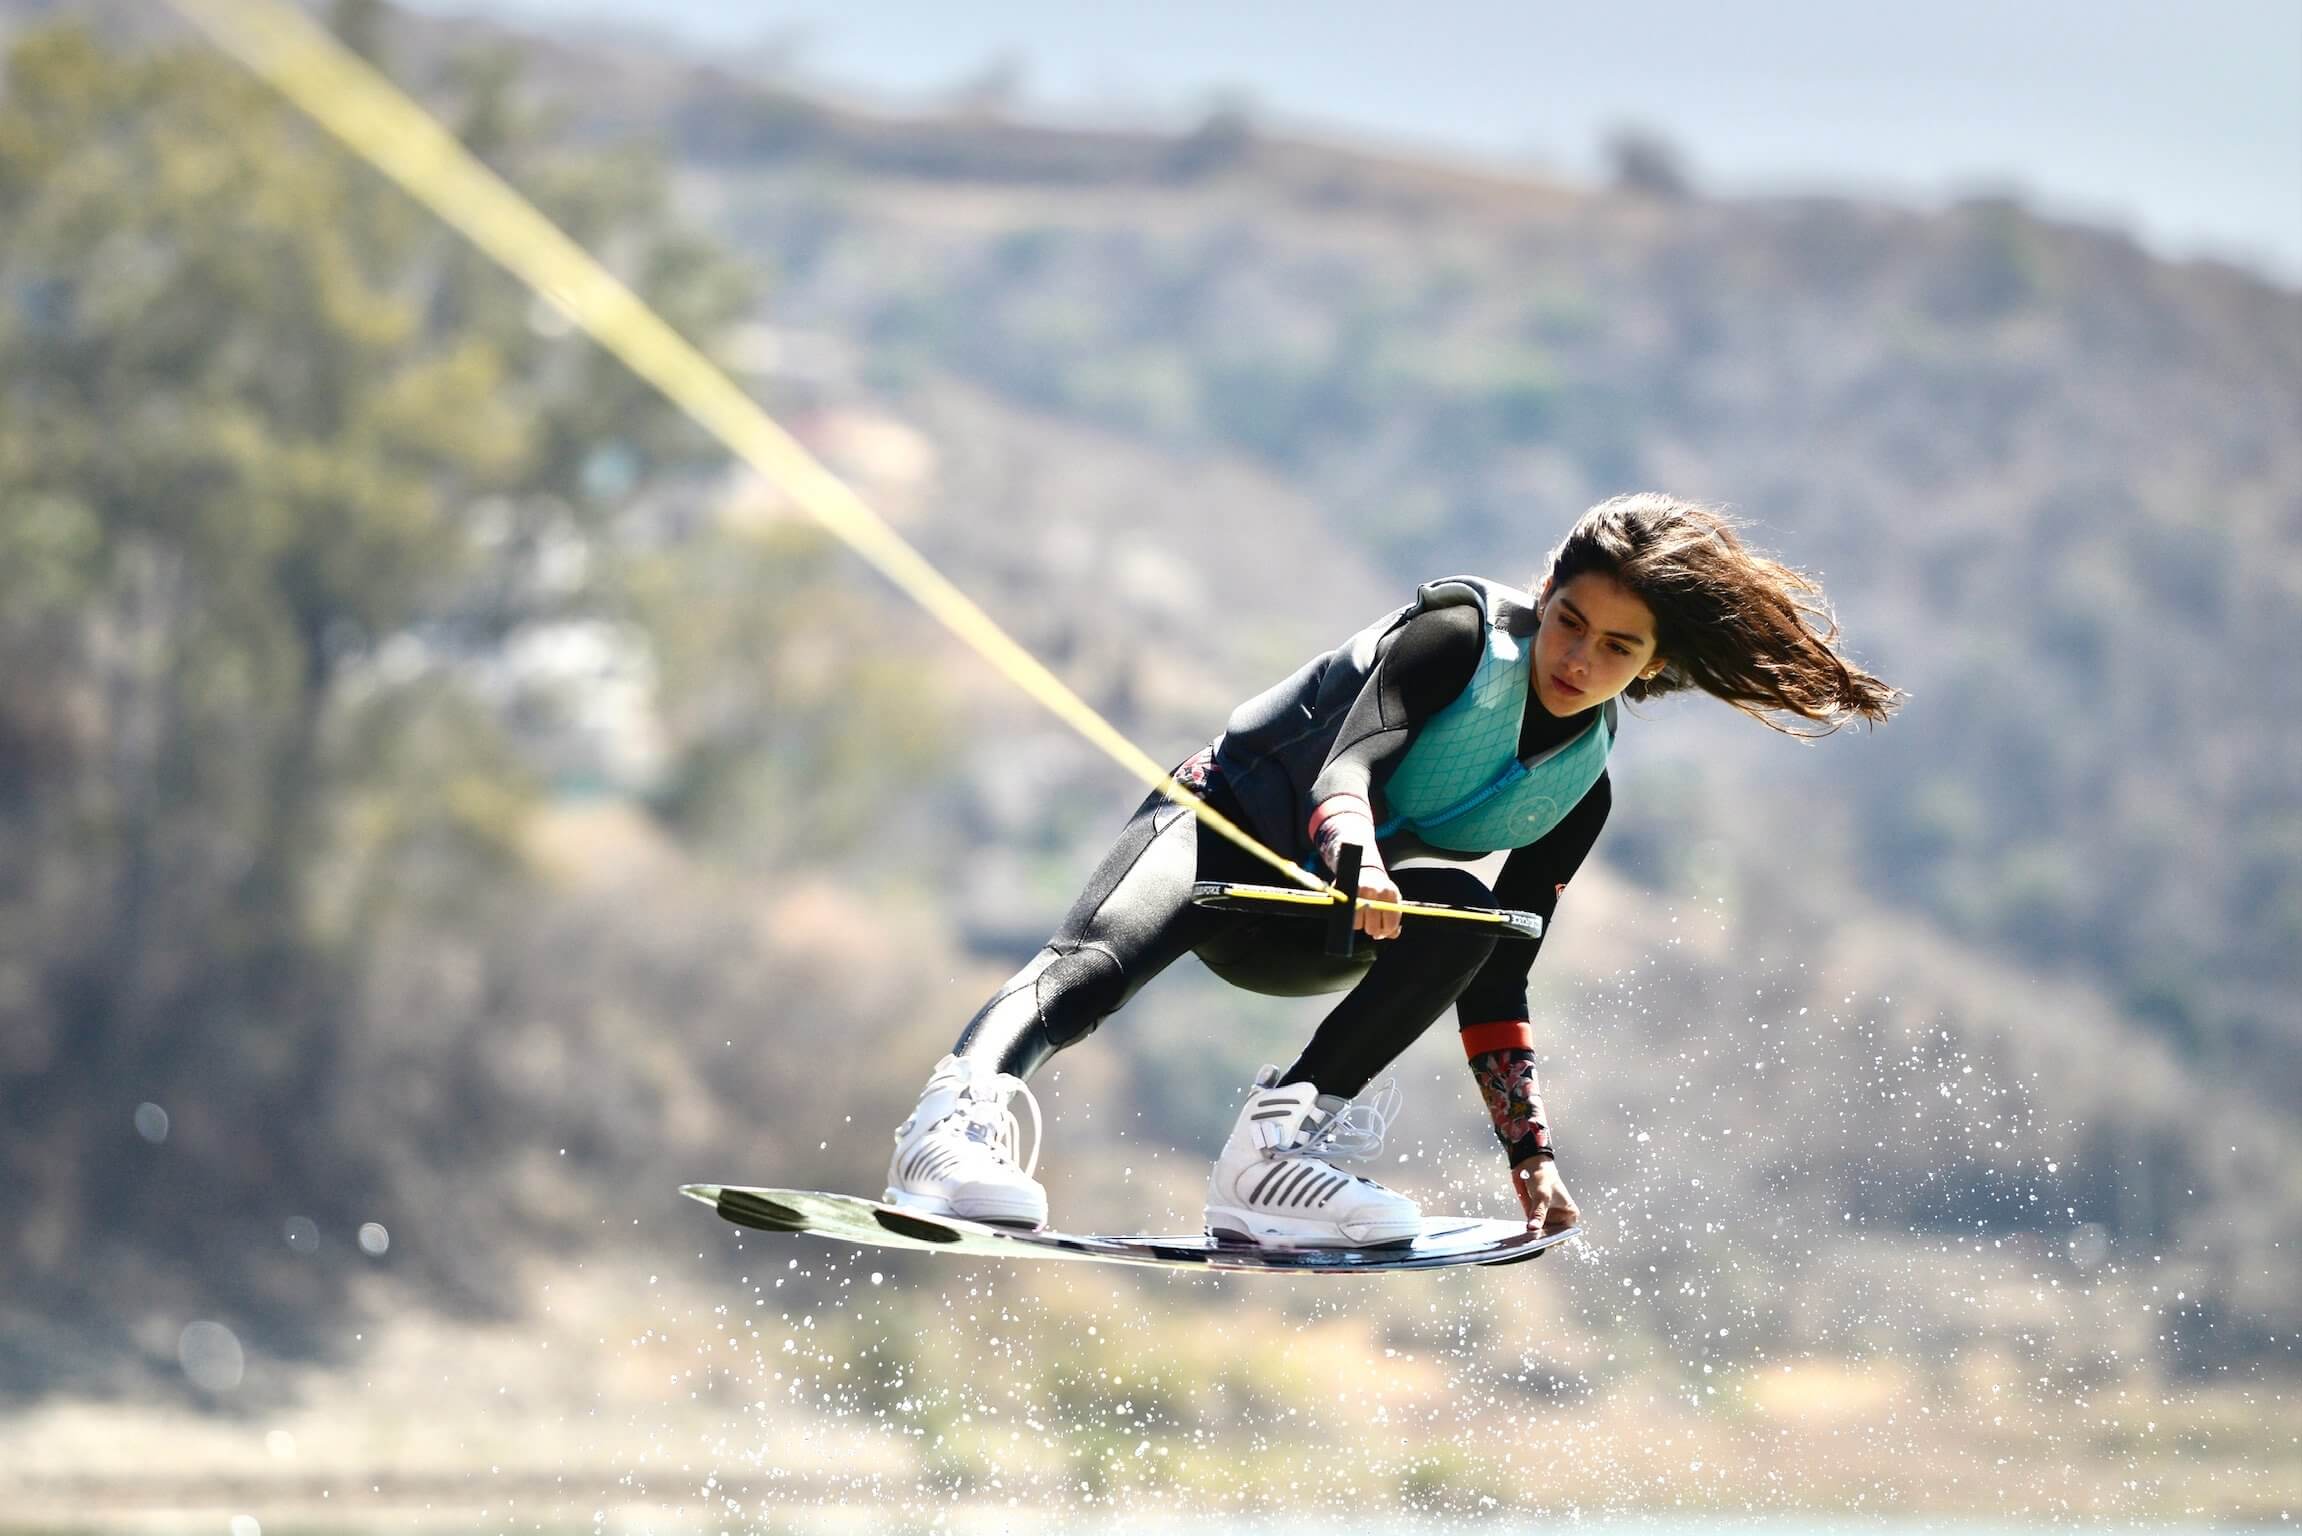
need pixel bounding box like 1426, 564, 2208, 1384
1538, 491, 1901, 737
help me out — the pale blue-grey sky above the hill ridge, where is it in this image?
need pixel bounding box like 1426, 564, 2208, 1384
417, 0, 2302, 283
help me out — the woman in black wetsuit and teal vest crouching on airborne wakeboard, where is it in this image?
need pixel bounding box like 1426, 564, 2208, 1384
886, 493, 1899, 1248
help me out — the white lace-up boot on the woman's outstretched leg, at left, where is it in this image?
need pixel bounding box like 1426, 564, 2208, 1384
886, 1055, 1047, 1227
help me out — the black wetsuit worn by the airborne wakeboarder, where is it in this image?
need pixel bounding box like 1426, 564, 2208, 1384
955, 606, 1609, 1098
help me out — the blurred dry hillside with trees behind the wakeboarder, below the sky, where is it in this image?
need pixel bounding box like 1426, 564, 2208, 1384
0, 2, 2302, 1510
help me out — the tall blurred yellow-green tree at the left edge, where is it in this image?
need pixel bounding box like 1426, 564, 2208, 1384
0, 17, 746, 1391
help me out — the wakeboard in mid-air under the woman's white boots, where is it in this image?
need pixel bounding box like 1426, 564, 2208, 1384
679, 1184, 1581, 1273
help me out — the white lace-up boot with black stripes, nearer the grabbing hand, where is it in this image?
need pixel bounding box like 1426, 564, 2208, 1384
1206, 1066, 1423, 1248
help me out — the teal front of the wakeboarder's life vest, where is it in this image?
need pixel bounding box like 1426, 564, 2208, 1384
1377, 583, 1616, 854
